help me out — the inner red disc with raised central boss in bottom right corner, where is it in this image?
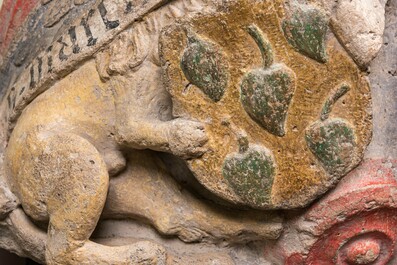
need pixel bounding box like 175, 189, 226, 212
306, 209, 397, 265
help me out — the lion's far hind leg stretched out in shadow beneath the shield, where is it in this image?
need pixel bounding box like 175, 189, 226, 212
103, 151, 282, 244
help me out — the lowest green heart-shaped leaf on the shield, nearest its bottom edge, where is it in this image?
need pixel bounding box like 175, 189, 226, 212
223, 146, 275, 207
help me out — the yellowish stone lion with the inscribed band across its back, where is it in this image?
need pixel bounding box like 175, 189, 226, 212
2, 1, 282, 264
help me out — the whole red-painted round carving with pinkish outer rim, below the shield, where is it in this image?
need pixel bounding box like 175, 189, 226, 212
279, 160, 397, 265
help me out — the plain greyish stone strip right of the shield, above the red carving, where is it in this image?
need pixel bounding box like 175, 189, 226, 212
366, 0, 397, 158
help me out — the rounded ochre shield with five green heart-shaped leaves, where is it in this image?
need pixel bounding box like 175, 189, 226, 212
160, 0, 372, 209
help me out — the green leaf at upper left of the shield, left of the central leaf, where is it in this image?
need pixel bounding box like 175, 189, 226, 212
181, 33, 229, 102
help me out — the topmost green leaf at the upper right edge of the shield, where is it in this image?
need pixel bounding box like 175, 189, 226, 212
282, 5, 328, 63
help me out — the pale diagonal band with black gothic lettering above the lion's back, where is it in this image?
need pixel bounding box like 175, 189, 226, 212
7, 0, 168, 124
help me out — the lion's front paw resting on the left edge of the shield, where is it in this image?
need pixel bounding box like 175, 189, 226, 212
168, 119, 208, 158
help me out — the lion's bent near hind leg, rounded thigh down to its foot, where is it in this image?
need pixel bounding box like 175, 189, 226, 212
34, 134, 165, 265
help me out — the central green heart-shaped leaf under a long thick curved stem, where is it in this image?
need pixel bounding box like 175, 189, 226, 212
241, 64, 295, 136
